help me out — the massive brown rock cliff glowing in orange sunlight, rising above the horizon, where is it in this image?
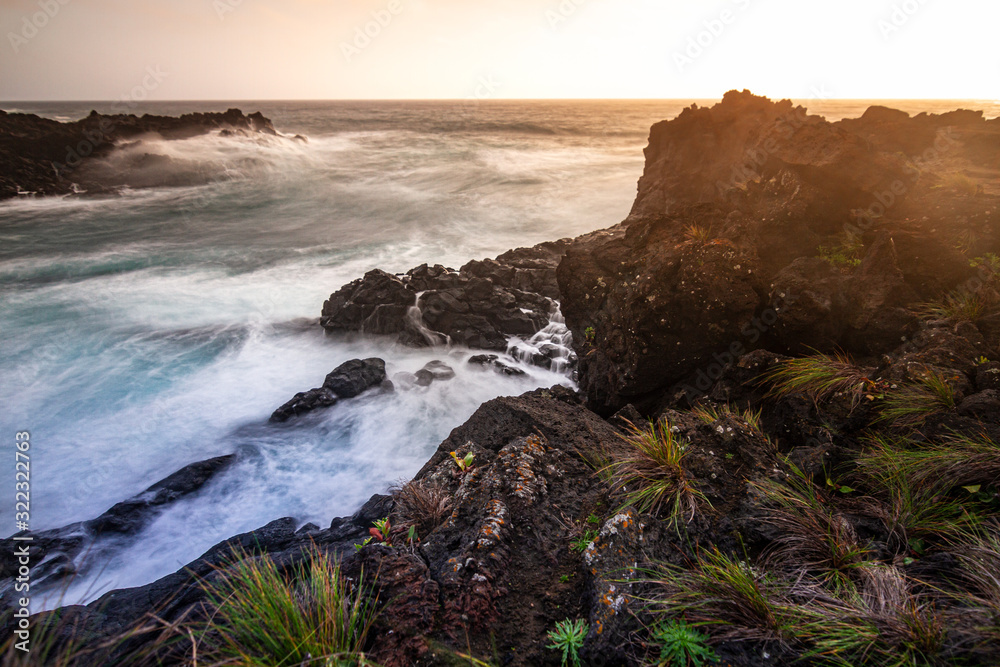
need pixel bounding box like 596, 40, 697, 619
557, 91, 1000, 415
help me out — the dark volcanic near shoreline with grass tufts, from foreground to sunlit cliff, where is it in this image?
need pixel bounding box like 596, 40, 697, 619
0, 91, 1000, 667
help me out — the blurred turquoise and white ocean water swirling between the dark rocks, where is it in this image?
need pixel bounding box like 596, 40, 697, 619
0, 100, 1000, 610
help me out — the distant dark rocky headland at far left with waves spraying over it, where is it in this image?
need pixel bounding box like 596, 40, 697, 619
0, 109, 277, 200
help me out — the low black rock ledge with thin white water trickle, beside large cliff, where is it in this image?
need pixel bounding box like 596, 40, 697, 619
321, 241, 568, 352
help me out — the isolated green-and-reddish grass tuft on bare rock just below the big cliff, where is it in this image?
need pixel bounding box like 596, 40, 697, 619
608, 419, 707, 529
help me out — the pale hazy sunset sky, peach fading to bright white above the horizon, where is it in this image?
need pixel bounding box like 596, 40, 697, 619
0, 0, 1000, 101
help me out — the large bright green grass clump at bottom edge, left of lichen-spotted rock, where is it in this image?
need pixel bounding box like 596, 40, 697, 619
199, 547, 377, 667
